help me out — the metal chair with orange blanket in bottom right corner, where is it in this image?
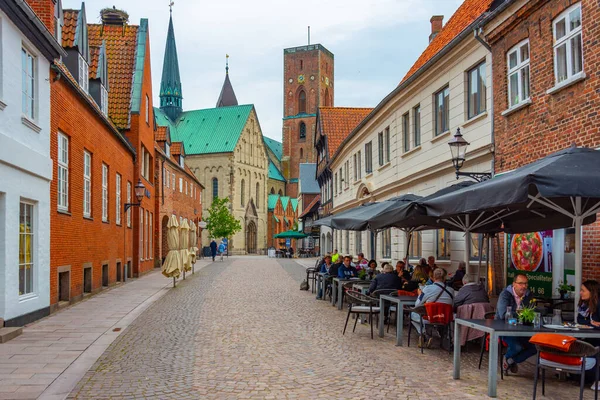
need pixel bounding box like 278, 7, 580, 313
533, 340, 600, 400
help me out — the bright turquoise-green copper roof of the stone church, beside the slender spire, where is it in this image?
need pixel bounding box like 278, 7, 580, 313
154, 104, 254, 156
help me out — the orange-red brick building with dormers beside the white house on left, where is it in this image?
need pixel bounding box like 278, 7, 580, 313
47, 0, 136, 311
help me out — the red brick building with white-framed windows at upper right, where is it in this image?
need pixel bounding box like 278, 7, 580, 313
485, 0, 600, 279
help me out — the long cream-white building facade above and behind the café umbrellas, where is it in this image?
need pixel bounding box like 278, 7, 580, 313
330, 10, 493, 278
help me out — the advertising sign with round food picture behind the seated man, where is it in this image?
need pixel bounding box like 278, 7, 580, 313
506, 231, 552, 297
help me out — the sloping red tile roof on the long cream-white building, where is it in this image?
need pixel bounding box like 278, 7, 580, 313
400, 0, 494, 83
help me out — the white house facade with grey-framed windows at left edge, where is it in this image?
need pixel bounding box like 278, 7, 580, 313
0, 0, 63, 327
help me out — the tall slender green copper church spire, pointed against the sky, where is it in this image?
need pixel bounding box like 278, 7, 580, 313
160, 1, 183, 121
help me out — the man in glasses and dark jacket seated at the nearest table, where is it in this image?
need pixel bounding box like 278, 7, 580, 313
496, 273, 537, 373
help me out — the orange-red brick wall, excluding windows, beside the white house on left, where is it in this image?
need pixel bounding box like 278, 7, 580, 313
50, 73, 134, 306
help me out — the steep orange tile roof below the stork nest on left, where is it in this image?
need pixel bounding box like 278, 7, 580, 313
88, 24, 139, 129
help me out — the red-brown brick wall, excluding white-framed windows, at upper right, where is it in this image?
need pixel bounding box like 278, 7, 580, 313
488, 0, 600, 279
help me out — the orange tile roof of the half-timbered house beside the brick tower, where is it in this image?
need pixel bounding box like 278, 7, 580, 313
319, 107, 373, 158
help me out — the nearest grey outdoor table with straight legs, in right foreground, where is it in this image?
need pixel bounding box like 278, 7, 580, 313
453, 318, 600, 397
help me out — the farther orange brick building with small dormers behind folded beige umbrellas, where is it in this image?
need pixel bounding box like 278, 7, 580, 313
154, 126, 204, 262
